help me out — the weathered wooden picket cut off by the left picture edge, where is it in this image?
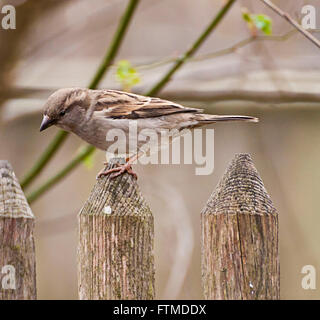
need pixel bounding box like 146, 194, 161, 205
0, 160, 37, 300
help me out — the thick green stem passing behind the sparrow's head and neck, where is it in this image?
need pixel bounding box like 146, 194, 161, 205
21, 0, 139, 188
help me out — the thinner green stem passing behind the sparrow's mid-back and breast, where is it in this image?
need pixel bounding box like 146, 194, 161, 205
27, 0, 235, 203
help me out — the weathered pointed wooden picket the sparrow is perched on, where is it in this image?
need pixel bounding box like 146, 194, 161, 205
78, 160, 154, 299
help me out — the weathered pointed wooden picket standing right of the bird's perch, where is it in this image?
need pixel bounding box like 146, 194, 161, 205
201, 154, 280, 300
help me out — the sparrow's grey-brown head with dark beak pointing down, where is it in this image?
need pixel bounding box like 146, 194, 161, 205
40, 88, 90, 131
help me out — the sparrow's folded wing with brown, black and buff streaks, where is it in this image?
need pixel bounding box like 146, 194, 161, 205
94, 90, 202, 119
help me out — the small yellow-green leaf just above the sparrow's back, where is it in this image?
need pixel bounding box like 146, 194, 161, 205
116, 60, 141, 91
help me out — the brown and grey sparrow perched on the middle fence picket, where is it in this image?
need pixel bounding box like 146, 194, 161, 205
40, 88, 258, 178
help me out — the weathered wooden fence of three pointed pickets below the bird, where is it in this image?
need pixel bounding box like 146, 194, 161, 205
0, 154, 280, 300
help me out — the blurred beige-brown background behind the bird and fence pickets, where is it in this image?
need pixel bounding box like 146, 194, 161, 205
0, 0, 320, 299
